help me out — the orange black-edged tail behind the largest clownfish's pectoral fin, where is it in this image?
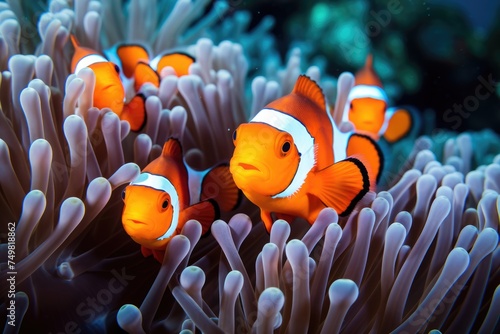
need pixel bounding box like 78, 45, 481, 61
346, 133, 384, 190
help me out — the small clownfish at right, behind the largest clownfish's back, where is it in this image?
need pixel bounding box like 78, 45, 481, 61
343, 55, 412, 143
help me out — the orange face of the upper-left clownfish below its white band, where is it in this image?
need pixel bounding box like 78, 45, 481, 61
89, 62, 125, 116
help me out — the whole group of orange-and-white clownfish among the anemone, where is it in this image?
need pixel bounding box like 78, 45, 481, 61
67, 36, 412, 262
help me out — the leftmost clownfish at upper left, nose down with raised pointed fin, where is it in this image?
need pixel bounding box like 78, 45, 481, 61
71, 35, 146, 131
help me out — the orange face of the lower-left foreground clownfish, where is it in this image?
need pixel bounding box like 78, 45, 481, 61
122, 185, 173, 248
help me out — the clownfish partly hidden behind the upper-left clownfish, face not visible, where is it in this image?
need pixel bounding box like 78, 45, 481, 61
107, 44, 195, 92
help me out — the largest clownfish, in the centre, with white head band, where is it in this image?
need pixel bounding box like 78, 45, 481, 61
230, 75, 373, 231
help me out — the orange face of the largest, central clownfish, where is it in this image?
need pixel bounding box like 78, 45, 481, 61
229, 123, 300, 196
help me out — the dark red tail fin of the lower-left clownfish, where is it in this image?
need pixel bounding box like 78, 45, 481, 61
200, 164, 243, 212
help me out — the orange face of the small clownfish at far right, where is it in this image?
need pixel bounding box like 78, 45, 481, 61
349, 98, 386, 135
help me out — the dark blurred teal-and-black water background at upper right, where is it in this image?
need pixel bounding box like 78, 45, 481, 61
232, 0, 500, 133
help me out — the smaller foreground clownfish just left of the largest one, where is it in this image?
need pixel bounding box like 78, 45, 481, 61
122, 138, 241, 263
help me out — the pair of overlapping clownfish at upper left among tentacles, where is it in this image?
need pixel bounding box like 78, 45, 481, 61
71, 35, 195, 132
